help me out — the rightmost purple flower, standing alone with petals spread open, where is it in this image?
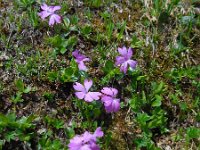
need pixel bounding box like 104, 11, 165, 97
115, 46, 137, 73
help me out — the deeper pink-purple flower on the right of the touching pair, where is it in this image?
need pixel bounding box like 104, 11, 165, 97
101, 87, 120, 113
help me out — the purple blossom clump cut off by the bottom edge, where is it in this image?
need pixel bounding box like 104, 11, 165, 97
68, 127, 103, 150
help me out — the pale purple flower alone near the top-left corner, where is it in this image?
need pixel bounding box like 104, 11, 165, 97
38, 4, 61, 26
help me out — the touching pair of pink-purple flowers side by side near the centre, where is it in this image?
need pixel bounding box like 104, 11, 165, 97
73, 79, 120, 113
